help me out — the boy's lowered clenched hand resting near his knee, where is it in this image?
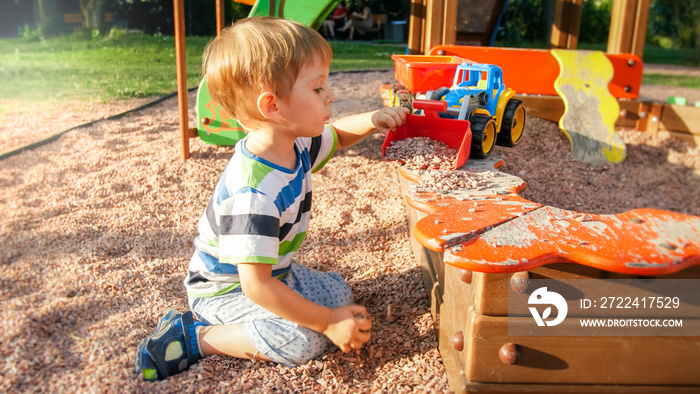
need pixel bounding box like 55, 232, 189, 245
323, 305, 372, 353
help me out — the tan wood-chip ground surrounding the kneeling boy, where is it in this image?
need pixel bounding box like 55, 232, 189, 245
0, 71, 700, 393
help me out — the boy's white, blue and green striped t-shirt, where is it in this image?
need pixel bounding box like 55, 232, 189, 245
185, 126, 337, 297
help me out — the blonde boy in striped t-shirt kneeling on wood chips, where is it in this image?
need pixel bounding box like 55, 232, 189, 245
136, 17, 406, 380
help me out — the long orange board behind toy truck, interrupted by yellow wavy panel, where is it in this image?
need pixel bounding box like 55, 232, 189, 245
424, 45, 644, 99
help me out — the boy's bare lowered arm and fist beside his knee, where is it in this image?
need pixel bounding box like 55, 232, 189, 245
238, 263, 372, 352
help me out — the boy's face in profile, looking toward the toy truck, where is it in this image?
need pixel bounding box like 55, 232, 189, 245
280, 59, 335, 137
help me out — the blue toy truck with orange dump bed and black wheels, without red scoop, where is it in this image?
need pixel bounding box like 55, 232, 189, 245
390, 55, 527, 159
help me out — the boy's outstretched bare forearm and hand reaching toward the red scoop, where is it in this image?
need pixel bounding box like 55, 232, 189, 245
333, 107, 409, 149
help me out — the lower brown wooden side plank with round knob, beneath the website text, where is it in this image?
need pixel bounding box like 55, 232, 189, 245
463, 312, 700, 386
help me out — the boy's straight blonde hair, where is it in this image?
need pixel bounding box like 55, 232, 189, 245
202, 17, 333, 130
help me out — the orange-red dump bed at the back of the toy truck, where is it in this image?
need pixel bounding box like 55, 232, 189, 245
391, 55, 465, 93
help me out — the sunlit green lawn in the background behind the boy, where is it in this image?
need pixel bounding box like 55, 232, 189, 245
0, 35, 405, 106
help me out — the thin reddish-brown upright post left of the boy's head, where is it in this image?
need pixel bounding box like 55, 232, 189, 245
173, 0, 190, 160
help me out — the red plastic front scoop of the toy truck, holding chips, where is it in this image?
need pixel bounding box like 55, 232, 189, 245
382, 100, 472, 169
